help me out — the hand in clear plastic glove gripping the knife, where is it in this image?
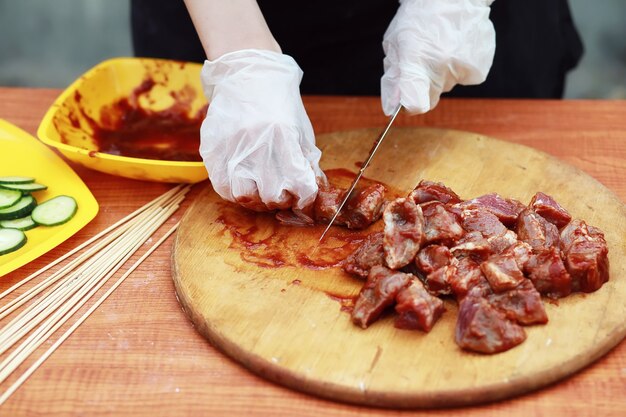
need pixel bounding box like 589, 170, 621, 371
381, 0, 495, 115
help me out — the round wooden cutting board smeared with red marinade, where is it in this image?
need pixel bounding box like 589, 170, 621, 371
172, 128, 626, 408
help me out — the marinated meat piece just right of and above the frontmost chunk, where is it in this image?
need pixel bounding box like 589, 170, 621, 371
486, 279, 548, 325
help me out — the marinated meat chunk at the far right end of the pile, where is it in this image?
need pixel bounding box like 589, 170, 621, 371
561, 220, 609, 292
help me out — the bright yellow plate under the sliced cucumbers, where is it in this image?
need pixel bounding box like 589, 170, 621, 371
0, 119, 98, 276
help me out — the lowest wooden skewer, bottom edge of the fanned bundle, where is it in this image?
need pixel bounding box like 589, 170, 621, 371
0, 223, 178, 405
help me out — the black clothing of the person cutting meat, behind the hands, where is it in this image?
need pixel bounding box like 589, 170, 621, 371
131, 0, 583, 98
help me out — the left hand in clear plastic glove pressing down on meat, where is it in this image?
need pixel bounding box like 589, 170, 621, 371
200, 49, 326, 211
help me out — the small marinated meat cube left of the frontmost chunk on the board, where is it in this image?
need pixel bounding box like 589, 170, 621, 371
394, 279, 445, 332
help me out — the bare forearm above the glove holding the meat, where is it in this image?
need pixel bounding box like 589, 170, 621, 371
180, 0, 281, 60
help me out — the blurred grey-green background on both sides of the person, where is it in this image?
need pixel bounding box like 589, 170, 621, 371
0, 0, 626, 98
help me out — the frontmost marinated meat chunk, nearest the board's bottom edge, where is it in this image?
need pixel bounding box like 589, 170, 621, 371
455, 296, 526, 353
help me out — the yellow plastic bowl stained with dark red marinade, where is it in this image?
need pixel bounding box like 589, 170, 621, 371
37, 58, 207, 183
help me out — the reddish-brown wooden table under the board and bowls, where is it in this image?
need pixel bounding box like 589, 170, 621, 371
0, 88, 626, 417
